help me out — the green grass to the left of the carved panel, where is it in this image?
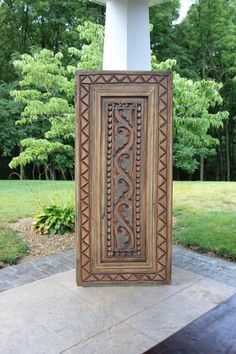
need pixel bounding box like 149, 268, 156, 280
0, 180, 74, 264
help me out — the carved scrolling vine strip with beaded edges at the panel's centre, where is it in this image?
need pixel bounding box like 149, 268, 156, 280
106, 100, 143, 257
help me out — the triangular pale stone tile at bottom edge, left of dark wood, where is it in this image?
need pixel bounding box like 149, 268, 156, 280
65, 323, 156, 354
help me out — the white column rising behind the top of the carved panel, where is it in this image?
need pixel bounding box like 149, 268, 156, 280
103, 0, 151, 70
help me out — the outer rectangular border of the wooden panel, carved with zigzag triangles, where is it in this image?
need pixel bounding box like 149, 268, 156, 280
76, 71, 172, 285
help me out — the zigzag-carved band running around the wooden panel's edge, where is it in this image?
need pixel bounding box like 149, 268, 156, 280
79, 73, 169, 283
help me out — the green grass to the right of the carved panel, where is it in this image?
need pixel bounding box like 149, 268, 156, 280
174, 182, 236, 261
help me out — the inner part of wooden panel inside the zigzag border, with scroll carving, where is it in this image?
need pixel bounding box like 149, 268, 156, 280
90, 87, 157, 272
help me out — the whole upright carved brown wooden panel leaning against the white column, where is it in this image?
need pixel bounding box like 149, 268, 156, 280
76, 71, 172, 285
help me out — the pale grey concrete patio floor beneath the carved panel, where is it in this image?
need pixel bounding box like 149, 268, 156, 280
0, 267, 236, 354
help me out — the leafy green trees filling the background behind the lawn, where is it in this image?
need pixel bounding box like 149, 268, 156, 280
0, 0, 236, 180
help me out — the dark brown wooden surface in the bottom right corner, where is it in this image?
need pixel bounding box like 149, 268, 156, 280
145, 295, 236, 354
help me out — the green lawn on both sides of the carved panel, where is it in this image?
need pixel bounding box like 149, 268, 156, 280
0, 180, 236, 263
